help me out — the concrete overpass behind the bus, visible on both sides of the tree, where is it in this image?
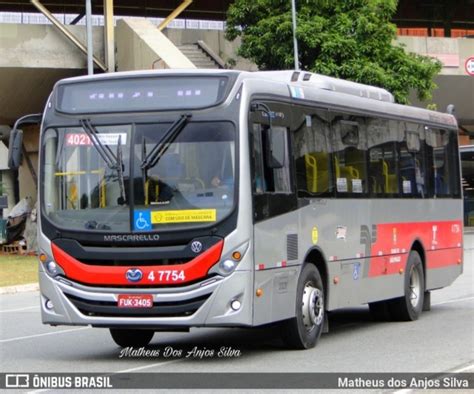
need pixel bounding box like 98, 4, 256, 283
0, 19, 474, 127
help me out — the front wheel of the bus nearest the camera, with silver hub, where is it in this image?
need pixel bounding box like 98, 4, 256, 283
281, 264, 326, 349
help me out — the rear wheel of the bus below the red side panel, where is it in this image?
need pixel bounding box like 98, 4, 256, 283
389, 250, 425, 321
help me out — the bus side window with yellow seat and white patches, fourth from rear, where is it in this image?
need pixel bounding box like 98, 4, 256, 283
331, 113, 368, 197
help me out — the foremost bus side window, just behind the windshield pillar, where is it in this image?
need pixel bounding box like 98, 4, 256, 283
252, 105, 291, 194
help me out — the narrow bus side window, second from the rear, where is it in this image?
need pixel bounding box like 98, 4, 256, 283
399, 122, 427, 198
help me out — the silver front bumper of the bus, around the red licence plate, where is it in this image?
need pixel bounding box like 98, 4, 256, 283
39, 268, 253, 330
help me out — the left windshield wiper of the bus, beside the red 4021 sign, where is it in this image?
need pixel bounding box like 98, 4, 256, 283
79, 119, 125, 205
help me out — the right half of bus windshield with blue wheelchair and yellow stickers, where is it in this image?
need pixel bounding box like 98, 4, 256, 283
133, 122, 235, 231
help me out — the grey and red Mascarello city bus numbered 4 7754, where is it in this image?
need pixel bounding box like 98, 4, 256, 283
10, 70, 463, 349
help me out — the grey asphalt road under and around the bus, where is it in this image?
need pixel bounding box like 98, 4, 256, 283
0, 240, 474, 382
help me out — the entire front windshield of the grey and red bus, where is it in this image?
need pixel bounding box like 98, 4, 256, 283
42, 120, 236, 232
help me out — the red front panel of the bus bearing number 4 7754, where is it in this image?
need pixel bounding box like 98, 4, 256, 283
51, 241, 224, 286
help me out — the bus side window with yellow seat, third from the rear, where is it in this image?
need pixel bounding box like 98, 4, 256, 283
367, 118, 404, 197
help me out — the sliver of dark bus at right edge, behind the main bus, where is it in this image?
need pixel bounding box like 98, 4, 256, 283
459, 145, 474, 227
